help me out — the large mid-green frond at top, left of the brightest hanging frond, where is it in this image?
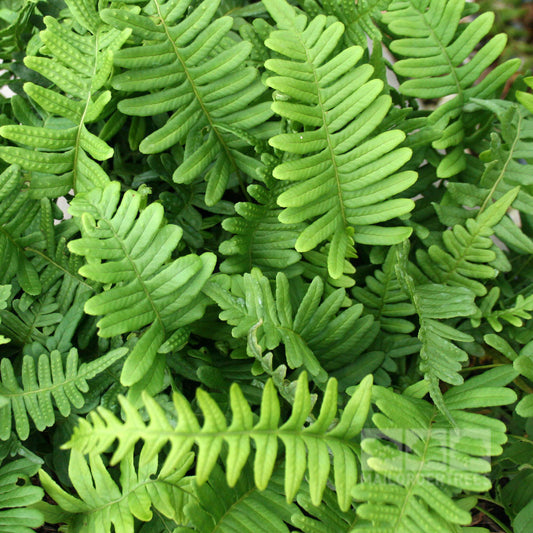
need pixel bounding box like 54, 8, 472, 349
101, 0, 272, 205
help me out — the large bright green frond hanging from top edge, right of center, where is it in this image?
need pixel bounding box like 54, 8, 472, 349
265, 0, 417, 278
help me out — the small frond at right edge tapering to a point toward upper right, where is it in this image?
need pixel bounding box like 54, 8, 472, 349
416, 188, 518, 296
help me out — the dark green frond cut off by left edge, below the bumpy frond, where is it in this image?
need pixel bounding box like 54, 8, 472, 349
0, 165, 41, 295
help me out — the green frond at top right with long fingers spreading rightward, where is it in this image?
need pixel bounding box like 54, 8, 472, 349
382, 0, 520, 178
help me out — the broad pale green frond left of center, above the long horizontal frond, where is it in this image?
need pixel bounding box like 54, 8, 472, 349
68, 182, 216, 385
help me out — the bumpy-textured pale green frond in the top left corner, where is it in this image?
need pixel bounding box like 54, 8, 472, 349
0, 0, 130, 197
